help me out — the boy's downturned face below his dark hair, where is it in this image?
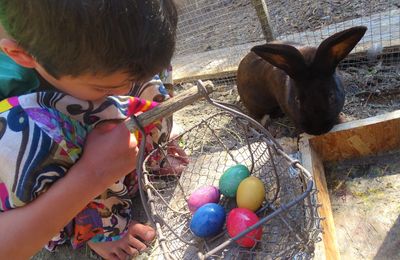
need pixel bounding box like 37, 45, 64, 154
36, 66, 133, 101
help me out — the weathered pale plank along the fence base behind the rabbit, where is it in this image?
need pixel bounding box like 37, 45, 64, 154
172, 9, 400, 82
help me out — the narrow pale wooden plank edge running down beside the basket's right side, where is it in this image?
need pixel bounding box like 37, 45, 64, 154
300, 136, 340, 260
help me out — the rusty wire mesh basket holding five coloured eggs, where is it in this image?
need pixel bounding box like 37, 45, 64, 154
134, 82, 321, 259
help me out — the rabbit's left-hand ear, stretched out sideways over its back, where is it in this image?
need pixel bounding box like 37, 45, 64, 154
251, 44, 307, 79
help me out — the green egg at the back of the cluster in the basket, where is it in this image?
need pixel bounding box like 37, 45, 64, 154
219, 164, 250, 198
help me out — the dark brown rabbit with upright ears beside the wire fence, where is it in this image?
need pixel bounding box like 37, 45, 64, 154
237, 26, 367, 135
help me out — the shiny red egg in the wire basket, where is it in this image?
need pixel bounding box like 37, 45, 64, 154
226, 208, 262, 247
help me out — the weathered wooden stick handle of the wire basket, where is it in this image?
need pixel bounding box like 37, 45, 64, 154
125, 80, 214, 131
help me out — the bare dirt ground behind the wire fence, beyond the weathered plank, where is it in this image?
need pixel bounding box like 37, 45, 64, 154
176, 0, 400, 55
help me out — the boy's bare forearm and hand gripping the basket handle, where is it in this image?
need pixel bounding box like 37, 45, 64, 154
0, 123, 138, 259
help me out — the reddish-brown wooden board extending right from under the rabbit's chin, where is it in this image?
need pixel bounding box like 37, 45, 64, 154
310, 110, 400, 162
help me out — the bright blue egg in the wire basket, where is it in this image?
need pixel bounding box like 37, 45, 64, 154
190, 203, 226, 237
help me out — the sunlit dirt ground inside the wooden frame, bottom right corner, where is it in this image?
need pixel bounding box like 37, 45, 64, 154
325, 151, 400, 259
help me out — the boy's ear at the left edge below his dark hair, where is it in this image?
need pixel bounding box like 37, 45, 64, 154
0, 39, 37, 68
